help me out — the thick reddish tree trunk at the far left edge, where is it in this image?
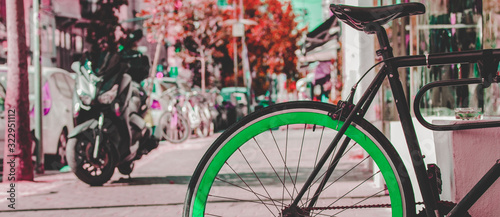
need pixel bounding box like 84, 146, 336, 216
3, 1, 33, 181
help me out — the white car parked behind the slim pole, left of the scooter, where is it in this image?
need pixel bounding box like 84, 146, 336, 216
0, 65, 75, 169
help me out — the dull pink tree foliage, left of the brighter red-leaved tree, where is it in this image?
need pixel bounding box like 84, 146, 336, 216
139, 0, 223, 91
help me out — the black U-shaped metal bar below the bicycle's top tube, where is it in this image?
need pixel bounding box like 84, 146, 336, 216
413, 76, 500, 131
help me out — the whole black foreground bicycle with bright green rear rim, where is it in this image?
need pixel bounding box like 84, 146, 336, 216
184, 3, 500, 217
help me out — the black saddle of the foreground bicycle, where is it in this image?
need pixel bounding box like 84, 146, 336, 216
330, 3, 425, 34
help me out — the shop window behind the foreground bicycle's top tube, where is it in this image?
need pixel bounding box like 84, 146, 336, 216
409, 0, 500, 116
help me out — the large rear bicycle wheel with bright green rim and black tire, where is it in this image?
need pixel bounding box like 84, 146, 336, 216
184, 102, 415, 217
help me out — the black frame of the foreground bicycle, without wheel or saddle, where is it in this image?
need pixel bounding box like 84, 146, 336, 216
292, 23, 500, 217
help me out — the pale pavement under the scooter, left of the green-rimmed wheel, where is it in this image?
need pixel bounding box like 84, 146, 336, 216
0, 134, 218, 217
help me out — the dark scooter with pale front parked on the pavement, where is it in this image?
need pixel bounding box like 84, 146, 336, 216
66, 32, 158, 186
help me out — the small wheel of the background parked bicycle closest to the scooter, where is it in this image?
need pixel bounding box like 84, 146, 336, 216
158, 112, 191, 144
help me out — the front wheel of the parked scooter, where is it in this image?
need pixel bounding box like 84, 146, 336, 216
66, 136, 116, 186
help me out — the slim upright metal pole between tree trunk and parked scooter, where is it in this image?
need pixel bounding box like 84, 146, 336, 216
32, 0, 45, 174
